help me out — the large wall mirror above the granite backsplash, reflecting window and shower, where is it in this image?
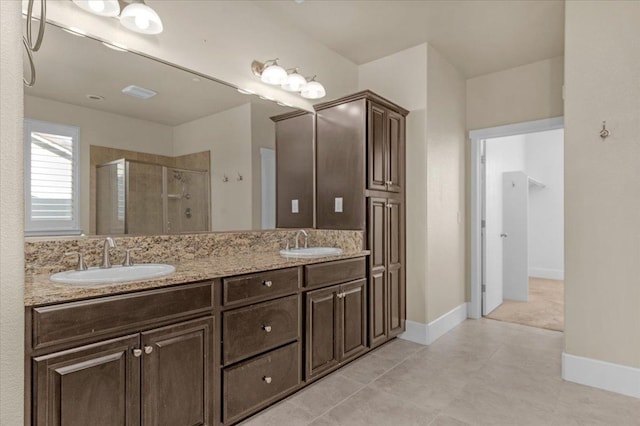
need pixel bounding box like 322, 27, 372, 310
24, 24, 293, 235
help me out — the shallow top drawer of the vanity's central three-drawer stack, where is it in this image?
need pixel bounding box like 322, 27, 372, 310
222, 268, 300, 306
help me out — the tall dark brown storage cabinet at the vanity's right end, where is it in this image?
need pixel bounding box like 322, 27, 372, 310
315, 91, 409, 347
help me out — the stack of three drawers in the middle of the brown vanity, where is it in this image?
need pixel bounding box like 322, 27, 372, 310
221, 267, 302, 424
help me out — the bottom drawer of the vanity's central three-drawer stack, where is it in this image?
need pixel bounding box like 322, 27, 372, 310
222, 343, 300, 423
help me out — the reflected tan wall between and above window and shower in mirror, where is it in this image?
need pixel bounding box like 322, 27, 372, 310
24, 96, 173, 233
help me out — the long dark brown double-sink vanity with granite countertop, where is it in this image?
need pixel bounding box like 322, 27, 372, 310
25, 251, 370, 426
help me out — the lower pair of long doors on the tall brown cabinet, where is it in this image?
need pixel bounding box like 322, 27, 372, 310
367, 197, 406, 347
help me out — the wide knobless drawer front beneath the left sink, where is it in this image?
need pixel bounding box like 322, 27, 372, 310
33, 282, 213, 349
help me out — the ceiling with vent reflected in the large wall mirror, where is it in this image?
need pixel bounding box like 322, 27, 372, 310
25, 25, 291, 126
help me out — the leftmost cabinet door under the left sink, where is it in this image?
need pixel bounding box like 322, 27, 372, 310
33, 334, 140, 426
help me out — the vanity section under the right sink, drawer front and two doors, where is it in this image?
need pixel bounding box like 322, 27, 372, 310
305, 259, 367, 381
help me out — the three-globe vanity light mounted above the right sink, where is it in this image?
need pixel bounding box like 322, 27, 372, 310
251, 58, 326, 99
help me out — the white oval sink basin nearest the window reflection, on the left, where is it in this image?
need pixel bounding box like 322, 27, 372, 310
49, 263, 176, 286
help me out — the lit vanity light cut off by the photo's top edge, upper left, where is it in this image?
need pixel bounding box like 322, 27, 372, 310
71, 0, 163, 34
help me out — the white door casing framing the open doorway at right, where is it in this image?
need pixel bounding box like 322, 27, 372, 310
467, 117, 564, 319
